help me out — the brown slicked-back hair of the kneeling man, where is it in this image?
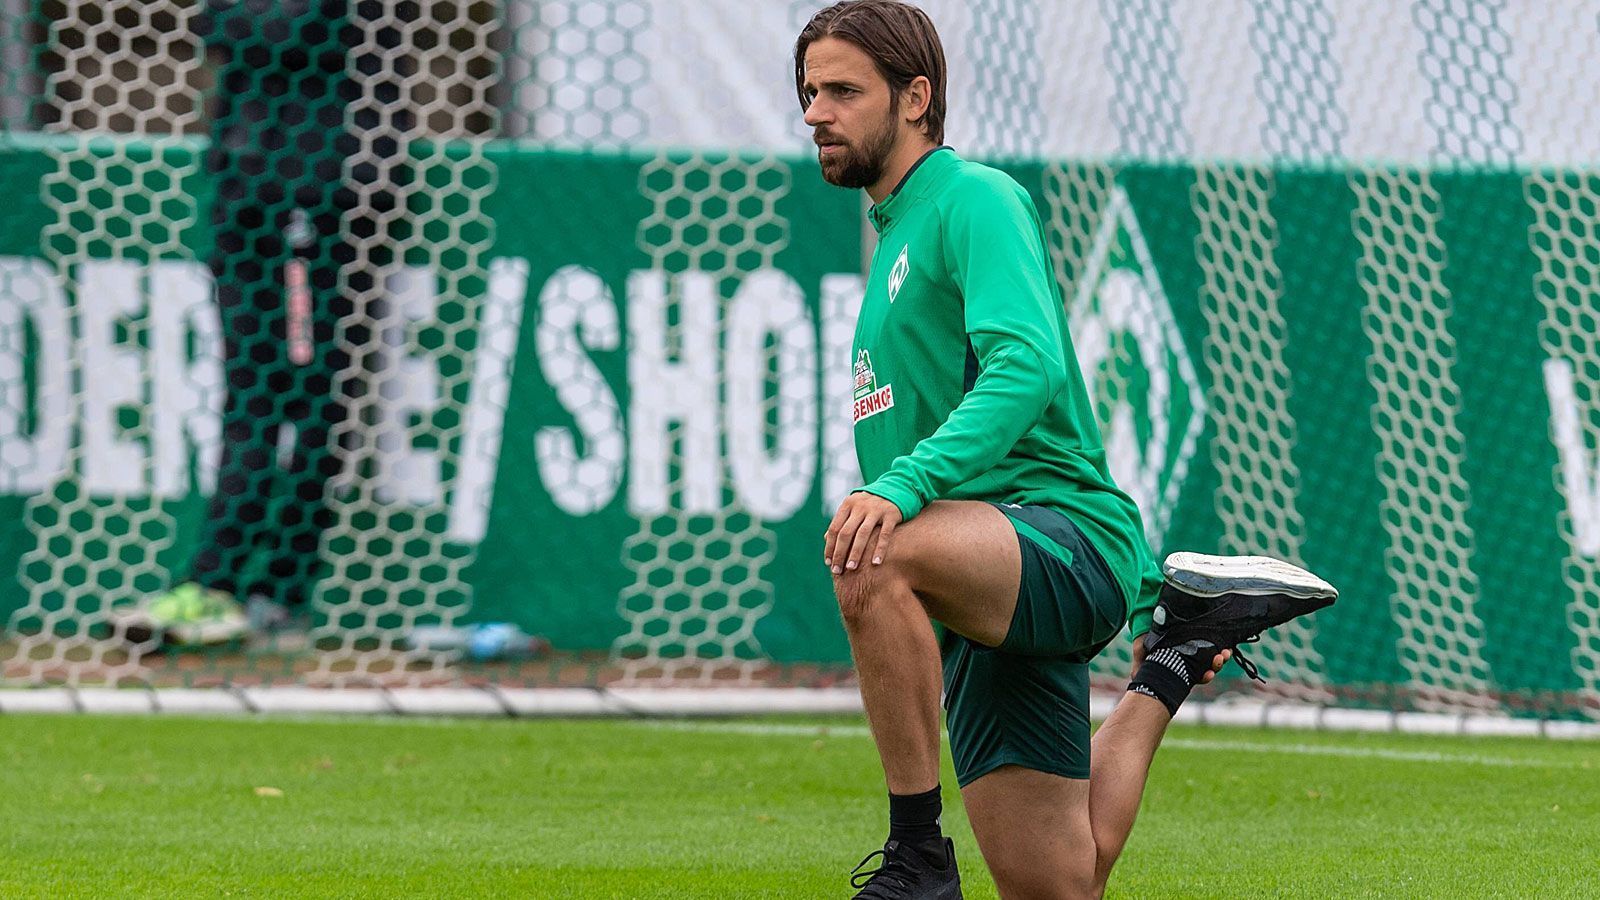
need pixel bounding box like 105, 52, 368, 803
795, 0, 944, 144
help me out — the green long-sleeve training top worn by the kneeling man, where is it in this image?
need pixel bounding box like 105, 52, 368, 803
851, 147, 1160, 636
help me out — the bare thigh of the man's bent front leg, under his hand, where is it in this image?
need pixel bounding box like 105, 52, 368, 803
837, 500, 1022, 647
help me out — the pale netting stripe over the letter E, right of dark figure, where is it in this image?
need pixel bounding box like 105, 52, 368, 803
312, 0, 496, 682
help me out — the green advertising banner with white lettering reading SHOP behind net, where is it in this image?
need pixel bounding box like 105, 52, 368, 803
0, 136, 1600, 714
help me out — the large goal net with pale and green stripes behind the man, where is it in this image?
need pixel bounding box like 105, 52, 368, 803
0, 0, 1600, 719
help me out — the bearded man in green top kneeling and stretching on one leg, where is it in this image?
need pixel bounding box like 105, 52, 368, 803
794, 0, 1336, 898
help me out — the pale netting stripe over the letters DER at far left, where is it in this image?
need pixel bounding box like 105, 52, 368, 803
0, 0, 209, 681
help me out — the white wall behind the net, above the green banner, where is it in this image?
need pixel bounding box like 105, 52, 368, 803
504, 0, 1600, 163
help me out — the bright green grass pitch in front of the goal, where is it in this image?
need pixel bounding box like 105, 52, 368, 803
0, 714, 1600, 898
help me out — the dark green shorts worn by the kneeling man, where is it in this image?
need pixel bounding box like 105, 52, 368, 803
944, 503, 1128, 788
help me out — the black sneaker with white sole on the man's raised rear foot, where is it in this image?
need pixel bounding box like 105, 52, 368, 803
1144, 552, 1339, 682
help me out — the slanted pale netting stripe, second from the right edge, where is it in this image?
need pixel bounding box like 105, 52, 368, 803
1350, 0, 1522, 708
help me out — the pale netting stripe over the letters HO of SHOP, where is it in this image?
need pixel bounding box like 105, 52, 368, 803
616, 154, 800, 681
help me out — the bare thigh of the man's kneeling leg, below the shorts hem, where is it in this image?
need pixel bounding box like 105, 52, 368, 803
962, 765, 1094, 900
